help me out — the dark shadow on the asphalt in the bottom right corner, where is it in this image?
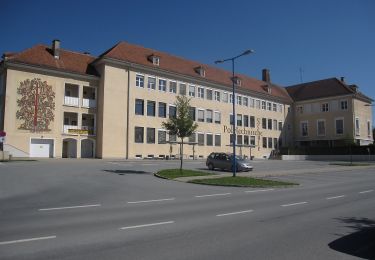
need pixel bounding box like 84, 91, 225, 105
328, 218, 375, 259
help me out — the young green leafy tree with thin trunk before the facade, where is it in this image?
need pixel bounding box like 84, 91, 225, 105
162, 96, 198, 171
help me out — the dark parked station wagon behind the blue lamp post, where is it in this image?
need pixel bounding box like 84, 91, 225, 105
206, 153, 253, 171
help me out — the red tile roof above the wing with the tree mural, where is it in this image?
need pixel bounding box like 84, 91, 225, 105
5, 45, 98, 76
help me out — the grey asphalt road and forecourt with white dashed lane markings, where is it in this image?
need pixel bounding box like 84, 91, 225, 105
0, 160, 375, 259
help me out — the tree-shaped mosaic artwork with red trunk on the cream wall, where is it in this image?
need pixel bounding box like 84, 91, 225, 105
16, 78, 55, 132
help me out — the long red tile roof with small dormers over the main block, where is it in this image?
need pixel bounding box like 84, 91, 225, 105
100, 42, 292, 102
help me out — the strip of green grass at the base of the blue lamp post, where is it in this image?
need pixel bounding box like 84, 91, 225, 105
189, 176, 298, 188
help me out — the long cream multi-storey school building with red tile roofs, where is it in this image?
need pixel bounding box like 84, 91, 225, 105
0, 40, 372, 158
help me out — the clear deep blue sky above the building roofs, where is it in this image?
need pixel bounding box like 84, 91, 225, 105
0, 0, 375, 121
